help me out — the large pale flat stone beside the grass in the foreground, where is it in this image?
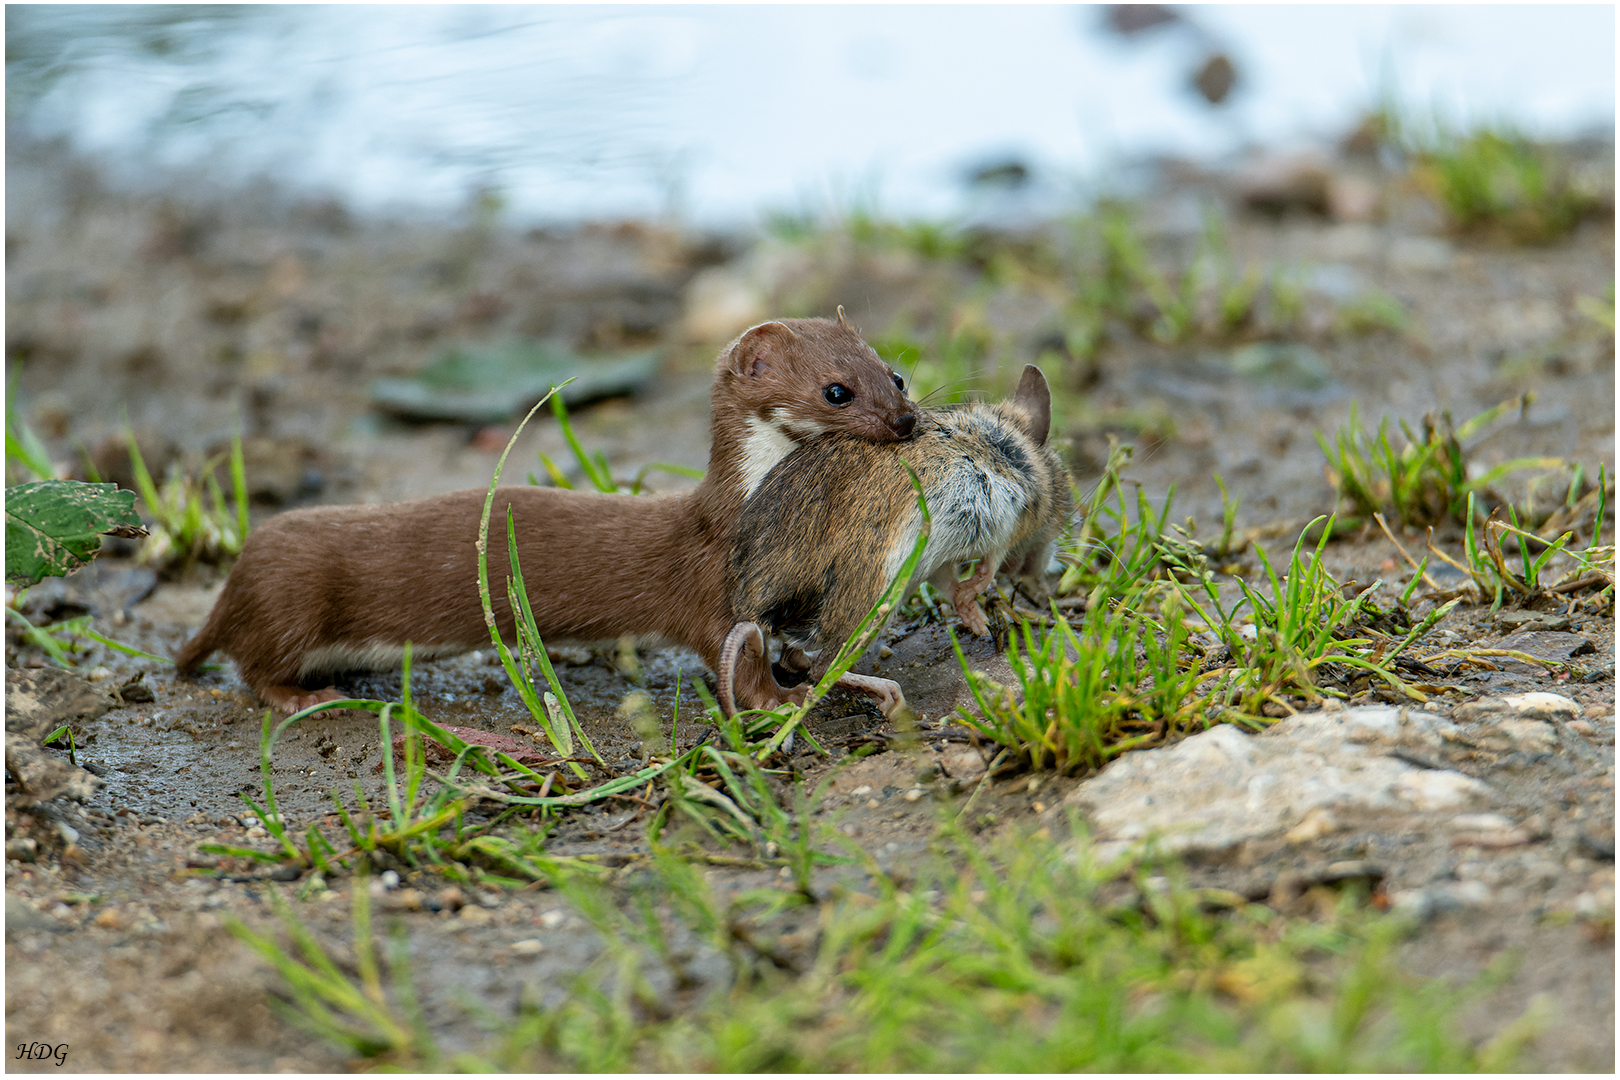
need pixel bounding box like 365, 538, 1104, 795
1066, 708, 1490, 857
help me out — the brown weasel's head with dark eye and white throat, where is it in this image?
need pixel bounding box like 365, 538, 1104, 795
711, 308, 917, 491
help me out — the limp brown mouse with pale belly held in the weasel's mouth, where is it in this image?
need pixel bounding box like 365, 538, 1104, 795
716, 364, 1074, 716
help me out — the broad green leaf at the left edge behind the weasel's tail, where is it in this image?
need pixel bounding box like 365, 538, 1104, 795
5, 479, 146, 585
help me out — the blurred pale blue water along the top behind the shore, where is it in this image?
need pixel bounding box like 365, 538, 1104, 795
6, 5, 1615, 227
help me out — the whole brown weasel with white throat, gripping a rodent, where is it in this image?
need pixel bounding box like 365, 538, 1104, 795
175, 317, 917, 712
